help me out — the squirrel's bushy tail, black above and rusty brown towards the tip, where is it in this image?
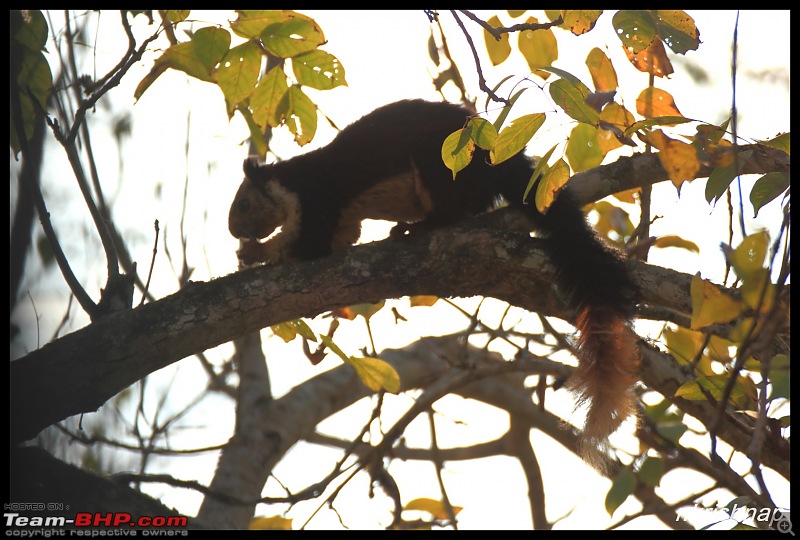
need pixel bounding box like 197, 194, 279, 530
526, 185, 639, 469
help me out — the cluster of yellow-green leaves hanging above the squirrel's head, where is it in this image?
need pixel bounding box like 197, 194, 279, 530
134, 10, 347, 156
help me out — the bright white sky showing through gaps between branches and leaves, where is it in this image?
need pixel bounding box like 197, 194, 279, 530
11, 11, 790, 529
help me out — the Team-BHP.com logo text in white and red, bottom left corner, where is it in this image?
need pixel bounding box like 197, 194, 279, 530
3, 512, 188, 537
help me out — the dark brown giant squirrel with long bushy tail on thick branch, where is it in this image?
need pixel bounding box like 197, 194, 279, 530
228, 100, 638, 467
